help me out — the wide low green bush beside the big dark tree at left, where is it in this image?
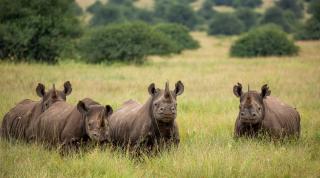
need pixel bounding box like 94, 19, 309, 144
79, 22, 178, 63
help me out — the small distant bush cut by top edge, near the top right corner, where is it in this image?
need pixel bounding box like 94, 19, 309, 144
276, 0, 303, 18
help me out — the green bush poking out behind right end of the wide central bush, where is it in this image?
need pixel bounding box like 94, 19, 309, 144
154, 23, 199, 51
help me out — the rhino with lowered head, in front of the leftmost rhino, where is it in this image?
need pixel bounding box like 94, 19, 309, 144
35, 98, 113, 150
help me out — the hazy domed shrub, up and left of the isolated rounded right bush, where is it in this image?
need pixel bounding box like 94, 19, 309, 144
208, 13, 245, 35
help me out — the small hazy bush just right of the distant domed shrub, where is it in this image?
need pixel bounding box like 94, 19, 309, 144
235, 8, 259, 31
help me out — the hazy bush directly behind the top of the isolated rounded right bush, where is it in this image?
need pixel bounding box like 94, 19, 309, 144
261, 7, 298, 32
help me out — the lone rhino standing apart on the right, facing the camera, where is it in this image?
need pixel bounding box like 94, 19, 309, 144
233, 83, 300, 138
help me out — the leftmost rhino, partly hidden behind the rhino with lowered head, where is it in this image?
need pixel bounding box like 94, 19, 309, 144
1, 81, 72, 141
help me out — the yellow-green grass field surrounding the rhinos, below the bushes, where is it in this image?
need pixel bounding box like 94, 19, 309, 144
0, 33, 320, 178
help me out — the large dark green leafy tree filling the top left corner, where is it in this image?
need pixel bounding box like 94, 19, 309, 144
0, 0, 81, 63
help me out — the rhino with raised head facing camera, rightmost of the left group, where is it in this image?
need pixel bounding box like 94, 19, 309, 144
110, 81, 184, 149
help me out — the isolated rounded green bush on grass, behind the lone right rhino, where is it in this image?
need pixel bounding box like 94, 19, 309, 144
230, 25, 298, 57
